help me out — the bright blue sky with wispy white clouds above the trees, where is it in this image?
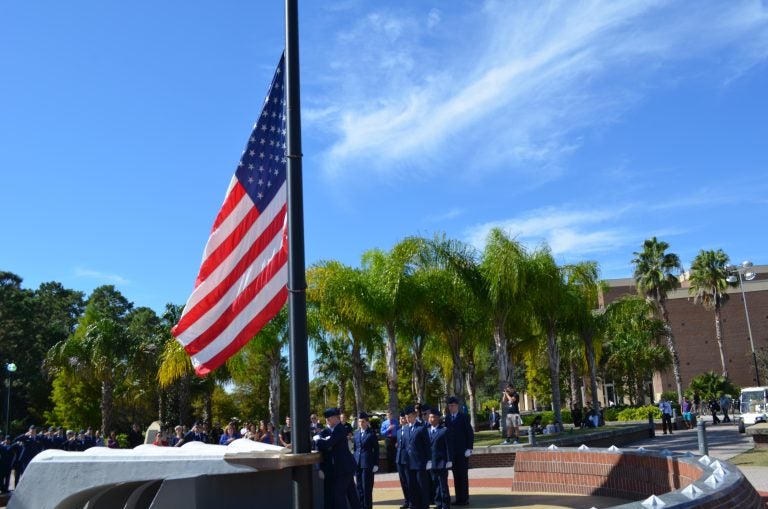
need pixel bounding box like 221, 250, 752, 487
0, 0, 768, 311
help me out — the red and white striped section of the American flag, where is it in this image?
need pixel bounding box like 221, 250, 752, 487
173, 177, 288, 376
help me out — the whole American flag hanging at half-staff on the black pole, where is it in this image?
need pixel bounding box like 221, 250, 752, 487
173, 57, 288, 376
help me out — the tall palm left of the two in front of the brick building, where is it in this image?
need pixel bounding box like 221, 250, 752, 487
632, 237, 683, 404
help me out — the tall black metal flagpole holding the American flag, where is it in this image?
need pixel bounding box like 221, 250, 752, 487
285, 0, 313, 509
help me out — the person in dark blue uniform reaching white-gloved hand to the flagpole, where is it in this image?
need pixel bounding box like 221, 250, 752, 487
312, 408, 360, 509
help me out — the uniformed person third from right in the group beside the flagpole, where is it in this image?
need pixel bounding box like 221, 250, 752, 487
405, 406, 430, 509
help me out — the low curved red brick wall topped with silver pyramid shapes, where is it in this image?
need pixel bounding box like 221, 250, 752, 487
512, 448, 765, 509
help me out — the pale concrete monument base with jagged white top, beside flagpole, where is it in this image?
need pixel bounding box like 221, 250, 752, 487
8, 439, 322, 509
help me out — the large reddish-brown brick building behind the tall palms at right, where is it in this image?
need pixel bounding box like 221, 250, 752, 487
604, 265, 768, 400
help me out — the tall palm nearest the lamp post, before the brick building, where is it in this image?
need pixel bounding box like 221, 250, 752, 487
688, 249, 729, 378
